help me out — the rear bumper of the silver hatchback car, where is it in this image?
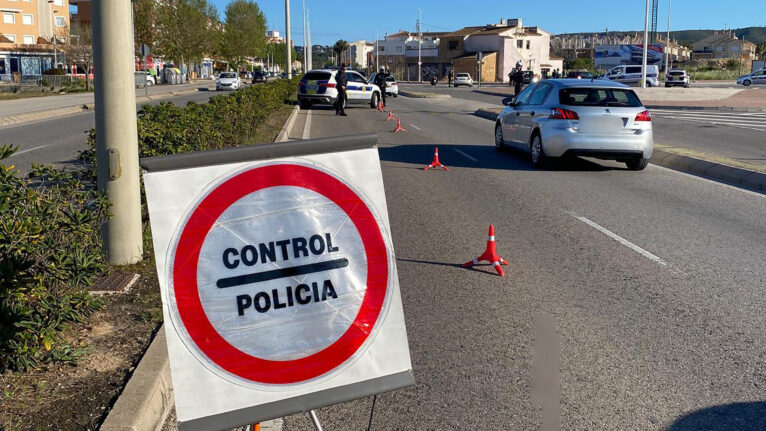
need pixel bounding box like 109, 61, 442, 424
542, 127, 654, 160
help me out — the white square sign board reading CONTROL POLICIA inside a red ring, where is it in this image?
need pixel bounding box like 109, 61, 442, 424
144, 137, 414, 430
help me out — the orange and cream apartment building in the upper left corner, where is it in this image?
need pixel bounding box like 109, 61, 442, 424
0, 0, 69, 82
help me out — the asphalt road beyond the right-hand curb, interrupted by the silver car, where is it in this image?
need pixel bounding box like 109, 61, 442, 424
402, 84, 766, 170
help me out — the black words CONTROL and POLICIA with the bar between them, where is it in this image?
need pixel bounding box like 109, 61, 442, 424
216, 233, 348, 316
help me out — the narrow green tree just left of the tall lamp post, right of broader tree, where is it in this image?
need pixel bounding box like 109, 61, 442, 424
218, 0, 266, 67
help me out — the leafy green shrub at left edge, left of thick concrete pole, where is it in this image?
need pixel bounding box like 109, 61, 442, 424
0, 145, 108, 372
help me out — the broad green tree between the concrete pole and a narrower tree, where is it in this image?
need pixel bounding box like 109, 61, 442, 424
154, 0, 219, 64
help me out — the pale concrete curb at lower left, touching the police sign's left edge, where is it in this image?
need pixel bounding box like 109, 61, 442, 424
100, 325, 173, 431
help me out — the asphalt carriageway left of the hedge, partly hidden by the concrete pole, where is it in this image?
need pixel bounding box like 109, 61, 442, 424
0, 87, 216, 172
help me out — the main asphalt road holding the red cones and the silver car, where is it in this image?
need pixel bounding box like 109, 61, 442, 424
284, 93, 766, 431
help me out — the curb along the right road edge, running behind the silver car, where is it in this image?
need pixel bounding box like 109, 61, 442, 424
474, 108, 766, 191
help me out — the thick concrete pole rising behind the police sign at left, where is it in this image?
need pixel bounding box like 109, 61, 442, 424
92, 0, 143, 265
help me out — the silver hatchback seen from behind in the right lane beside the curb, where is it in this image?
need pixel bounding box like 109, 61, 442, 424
495, 79, 654, 170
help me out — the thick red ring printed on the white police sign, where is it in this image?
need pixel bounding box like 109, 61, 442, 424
172, 164, 388, 384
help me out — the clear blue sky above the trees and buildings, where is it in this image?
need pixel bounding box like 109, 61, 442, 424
212, 0, 766, 45
